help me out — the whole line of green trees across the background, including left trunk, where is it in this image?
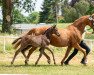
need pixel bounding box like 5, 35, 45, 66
0, 0, 94, 33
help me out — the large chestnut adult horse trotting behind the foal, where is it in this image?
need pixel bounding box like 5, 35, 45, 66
13, 14, 94, 65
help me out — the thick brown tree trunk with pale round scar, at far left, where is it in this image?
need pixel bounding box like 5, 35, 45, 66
2, 0, 12, 33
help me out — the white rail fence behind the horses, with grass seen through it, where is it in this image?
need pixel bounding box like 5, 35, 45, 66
0, 36, 94, 52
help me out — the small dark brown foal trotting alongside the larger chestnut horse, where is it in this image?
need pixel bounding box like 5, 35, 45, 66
11, 25, 60, 65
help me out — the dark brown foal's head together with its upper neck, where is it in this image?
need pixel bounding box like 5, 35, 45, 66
43, 25, 60, 38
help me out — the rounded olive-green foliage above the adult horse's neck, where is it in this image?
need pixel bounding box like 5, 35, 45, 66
62, 0, 94, 22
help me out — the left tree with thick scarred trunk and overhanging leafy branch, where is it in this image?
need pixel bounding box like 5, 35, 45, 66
0, 0, 35, 33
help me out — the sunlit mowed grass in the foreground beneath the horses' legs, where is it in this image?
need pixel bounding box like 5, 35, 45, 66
0, 47, 94, 75
